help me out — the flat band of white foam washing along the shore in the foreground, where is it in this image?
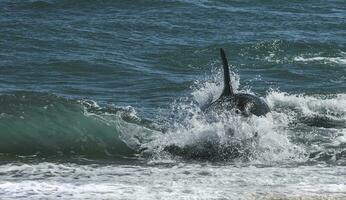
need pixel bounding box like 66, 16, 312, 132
0, 163, 346, 199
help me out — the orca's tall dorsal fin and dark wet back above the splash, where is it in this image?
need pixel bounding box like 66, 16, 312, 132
204, 48, 270, 116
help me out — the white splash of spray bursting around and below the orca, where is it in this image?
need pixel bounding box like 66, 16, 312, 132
144, 69, 304, 163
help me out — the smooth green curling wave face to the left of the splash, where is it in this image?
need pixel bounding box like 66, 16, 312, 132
0, 92, 155, 157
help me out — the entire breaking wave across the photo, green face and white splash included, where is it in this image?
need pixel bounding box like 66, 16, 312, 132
0, 72, 346, 164
